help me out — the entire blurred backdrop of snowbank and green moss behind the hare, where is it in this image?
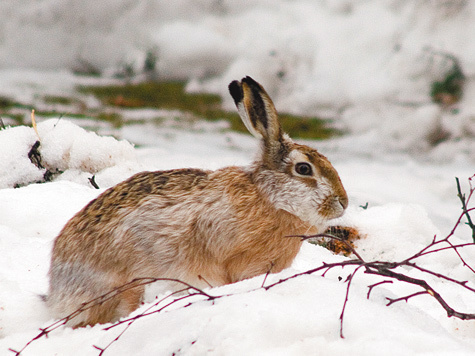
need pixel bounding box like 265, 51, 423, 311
0, 0, 475, 164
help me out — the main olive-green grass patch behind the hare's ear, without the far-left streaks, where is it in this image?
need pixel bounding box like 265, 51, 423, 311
78, 82, 337, 139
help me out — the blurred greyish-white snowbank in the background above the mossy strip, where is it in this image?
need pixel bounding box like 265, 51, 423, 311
0, 0, 475, 159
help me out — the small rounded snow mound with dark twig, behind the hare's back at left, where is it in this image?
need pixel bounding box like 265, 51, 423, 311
0, 119, 135, 188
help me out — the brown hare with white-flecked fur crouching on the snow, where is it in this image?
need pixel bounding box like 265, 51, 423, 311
47, 77, 348, 327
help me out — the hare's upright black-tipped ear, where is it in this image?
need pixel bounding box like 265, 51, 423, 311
229, 77, 283, 143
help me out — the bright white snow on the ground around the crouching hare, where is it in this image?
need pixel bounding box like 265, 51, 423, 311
0, 119, 475, 355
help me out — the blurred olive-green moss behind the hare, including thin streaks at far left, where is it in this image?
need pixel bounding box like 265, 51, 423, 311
0, 82, 338, 139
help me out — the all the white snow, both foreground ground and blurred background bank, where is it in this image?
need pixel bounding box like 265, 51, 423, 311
0, 0, 475, 355
